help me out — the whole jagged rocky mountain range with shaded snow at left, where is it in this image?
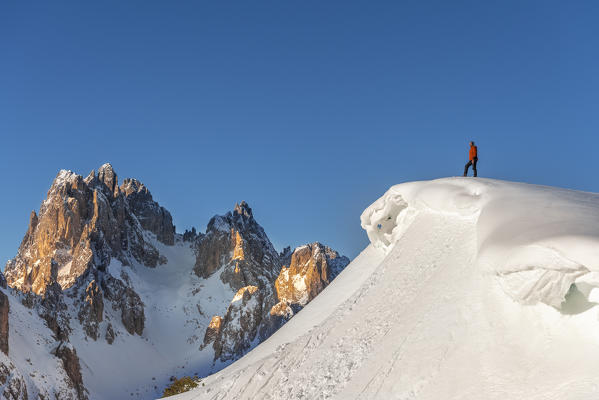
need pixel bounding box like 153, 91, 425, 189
0, 164, 349, 400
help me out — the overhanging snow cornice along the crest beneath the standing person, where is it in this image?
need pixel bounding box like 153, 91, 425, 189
361, 179, 599, 307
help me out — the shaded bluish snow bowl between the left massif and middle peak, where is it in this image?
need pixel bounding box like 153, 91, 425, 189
70, 240, 235, 399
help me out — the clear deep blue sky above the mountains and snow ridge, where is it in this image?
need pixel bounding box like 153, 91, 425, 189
0, 0, 599, 264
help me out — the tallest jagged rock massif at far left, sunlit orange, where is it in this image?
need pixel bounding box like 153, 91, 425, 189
5, 164, 174, 294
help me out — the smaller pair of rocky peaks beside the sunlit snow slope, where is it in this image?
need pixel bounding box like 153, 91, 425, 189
200, 209, 349, 361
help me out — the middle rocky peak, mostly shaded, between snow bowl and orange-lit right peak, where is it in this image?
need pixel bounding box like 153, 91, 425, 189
194, 201, 281, 361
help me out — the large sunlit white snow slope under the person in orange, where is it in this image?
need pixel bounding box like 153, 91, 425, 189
178, 178, 599, 400
